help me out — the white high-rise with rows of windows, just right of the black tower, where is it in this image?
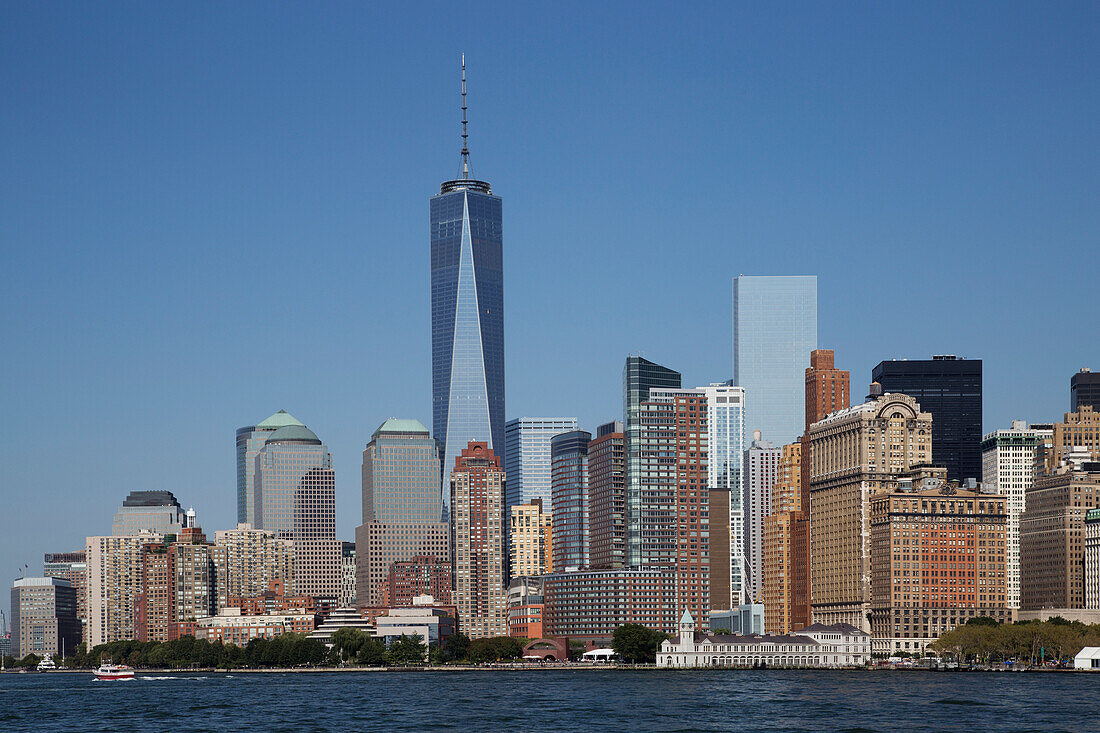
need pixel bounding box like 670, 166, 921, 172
985, 420, 1053, 609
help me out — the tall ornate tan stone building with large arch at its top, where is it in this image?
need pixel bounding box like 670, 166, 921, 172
807, 384, 932, 632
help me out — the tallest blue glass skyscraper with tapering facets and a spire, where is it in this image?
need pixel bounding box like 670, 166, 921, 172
430, 63, 505, 508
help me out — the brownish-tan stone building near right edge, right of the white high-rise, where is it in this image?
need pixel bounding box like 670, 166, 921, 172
1020, 451, 1100, 611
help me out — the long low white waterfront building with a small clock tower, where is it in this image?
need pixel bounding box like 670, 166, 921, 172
657, 611, 871, 668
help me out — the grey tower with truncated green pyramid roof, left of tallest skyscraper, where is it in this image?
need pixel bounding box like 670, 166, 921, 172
355, 418, 451, 608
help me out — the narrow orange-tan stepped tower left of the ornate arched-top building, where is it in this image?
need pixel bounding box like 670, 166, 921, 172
763, 442, 802, 634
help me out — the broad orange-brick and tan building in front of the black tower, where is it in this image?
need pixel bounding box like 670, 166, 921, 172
871, 479, 1012, 653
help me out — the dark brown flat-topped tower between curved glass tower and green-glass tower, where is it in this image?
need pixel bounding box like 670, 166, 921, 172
589, 420, 626, 569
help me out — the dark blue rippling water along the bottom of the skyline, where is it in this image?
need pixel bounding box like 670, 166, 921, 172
0, 670, 1100, 733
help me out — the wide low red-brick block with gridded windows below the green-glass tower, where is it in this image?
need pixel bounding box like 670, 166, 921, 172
541, 568, 677, 643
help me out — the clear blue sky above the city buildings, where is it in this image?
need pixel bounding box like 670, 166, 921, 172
0, 2, 1100, 602
